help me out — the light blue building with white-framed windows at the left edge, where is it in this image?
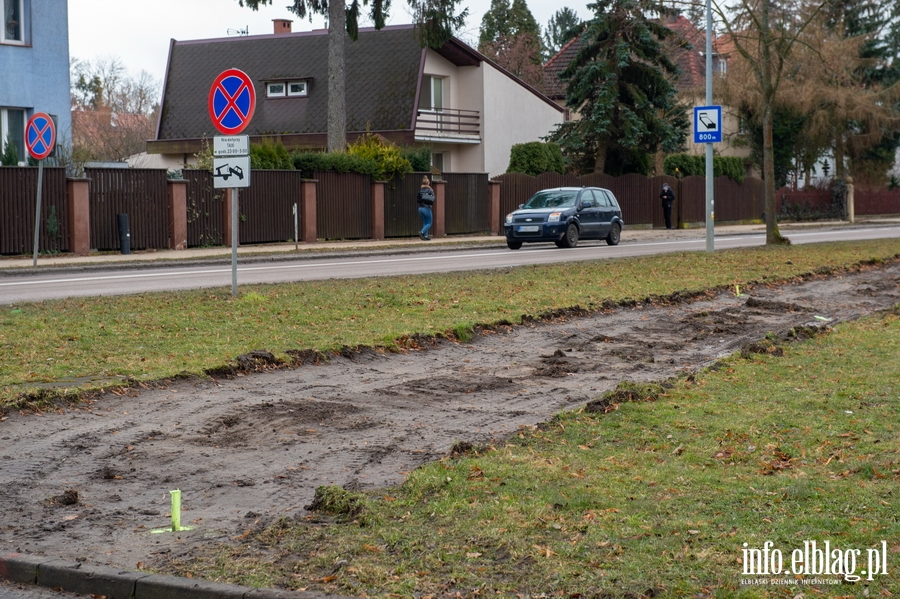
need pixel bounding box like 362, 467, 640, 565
0, 0, 72, 162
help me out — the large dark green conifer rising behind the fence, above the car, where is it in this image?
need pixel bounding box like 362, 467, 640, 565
550, 0, 687, 172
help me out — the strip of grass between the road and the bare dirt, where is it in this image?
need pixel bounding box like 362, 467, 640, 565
0, 240, 900, 408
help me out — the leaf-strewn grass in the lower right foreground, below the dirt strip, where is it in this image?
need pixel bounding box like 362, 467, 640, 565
158, 309, 900, 597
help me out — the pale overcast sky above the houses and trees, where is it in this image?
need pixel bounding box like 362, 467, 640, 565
69, 0, 590, 89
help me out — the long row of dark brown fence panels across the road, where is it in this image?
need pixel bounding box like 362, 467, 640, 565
0, 167, 900, 254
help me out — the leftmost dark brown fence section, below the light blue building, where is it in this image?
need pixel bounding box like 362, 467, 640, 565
0, 166, 70, 254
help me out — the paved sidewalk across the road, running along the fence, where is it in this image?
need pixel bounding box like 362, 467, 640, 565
0, 218, 900, 274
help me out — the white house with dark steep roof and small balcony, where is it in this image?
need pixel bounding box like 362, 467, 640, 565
148, 24, 564, 175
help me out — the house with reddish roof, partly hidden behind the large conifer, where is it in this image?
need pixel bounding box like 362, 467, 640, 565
544, 15, 749, 162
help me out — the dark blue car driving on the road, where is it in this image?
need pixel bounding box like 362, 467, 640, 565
504, 187, 625, 250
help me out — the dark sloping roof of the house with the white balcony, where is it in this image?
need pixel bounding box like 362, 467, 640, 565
157, 26, 432, 139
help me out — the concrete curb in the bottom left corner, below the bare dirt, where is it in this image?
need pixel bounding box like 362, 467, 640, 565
0, 552, 354, 599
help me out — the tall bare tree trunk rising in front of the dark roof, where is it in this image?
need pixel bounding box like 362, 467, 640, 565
328, 1, 347, 152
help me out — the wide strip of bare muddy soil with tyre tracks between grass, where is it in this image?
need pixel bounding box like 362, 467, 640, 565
0, 264, 900, 568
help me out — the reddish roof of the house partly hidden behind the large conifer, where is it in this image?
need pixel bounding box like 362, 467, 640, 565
544, 15, 706, 100
